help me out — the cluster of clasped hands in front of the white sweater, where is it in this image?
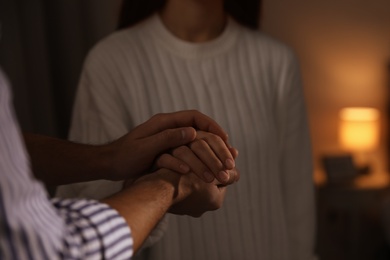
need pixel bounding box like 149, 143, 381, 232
111, 110, 240, 217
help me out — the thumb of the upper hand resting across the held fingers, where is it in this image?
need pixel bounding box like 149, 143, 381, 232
144, 127, 196, 154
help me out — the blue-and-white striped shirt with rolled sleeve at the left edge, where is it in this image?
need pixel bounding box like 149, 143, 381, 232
0, 70, 133, 260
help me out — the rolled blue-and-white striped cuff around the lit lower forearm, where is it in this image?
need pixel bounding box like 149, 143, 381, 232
52, 198, 133, 259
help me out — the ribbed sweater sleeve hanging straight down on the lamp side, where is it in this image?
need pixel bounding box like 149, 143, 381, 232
278, 49, 315, 260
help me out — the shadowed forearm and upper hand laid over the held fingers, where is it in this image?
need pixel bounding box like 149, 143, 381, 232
24, 110, 232, 185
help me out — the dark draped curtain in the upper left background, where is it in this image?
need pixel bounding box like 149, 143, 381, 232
0, 0, 121, 138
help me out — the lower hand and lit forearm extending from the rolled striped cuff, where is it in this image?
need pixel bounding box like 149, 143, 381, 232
103, 169, 230, 251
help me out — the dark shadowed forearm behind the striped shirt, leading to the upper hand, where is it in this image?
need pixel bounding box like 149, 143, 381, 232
23, 134, 110, 185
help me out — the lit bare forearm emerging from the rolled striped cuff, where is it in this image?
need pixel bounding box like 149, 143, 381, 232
102, 171, 180, 252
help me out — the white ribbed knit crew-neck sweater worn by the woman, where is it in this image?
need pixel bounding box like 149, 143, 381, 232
55, 15, 315, 260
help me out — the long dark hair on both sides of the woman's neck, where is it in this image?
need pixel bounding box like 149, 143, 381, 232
118, 0, 260, 29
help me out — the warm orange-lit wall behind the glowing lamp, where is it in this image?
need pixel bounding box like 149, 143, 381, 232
262, 0, 390, 175
